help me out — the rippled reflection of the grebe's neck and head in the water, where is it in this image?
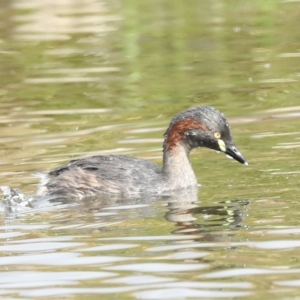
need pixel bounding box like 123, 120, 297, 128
165, 190, 250, 241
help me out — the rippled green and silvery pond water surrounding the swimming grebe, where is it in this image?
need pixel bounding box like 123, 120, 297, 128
0, 0, 300, 299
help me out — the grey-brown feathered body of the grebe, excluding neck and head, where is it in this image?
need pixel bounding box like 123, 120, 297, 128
45, 155, 163, 198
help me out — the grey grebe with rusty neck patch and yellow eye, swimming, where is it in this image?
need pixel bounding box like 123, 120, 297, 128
38, 106, 248, 198
